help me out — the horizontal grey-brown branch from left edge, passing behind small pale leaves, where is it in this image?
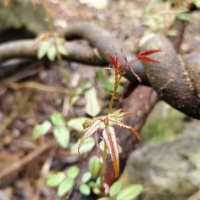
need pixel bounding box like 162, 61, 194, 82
0, 40, 107, 66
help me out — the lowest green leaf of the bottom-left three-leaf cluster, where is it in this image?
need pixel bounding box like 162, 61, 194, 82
57, 179, 74, 197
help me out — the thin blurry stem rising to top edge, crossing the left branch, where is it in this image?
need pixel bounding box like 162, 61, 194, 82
41, 0, 71, 97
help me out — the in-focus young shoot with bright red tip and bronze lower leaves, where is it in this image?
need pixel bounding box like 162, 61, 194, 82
78, 49, 161, 178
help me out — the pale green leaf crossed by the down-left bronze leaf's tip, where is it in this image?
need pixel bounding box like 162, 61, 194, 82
70, 137, 95, 154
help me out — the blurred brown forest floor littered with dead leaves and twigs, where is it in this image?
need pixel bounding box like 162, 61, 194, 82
0, 0, 200, 200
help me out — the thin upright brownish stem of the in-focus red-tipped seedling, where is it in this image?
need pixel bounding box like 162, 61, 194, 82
100, 66, 120, 186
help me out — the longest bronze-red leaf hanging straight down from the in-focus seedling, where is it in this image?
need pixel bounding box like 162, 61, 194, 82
103, 126, 119, 178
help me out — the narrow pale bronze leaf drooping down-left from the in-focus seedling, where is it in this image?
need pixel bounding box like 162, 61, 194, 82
78, 120, 101, 154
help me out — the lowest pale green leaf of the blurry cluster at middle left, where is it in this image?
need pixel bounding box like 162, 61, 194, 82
53, 126, 70, 148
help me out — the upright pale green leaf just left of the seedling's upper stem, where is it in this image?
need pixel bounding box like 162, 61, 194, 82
85, 87, 101, 117
